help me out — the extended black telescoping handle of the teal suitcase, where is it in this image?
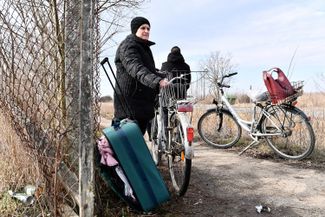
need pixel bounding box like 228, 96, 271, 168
100, 57, 134, 119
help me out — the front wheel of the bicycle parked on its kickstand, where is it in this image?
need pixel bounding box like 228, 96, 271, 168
198, 109, 241, 148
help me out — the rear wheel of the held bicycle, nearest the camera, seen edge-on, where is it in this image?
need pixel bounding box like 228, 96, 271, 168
167, 115, 192, 196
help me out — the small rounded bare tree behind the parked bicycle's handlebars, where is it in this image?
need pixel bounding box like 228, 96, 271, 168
201, 51, 237, 95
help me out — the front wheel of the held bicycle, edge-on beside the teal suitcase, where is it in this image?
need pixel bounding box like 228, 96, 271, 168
150, 113, 162, 165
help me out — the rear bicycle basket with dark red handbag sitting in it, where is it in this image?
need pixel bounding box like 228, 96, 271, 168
263, 68, 303, 104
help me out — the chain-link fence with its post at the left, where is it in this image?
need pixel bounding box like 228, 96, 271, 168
0, 0, 99, 216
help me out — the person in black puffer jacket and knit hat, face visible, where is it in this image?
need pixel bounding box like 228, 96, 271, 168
114, 17, 168, 134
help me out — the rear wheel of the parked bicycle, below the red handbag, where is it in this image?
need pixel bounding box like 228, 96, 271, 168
261, 105, 315, 160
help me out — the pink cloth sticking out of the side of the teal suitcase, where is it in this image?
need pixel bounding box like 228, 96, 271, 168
97, 136, 118, 166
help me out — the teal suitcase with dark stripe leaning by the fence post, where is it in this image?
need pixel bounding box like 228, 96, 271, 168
103, 120, 170, 212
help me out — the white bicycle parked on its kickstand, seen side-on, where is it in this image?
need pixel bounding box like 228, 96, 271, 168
198, 69, 315, 160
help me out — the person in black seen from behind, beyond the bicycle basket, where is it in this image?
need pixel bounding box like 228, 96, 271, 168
160, 46, 191, 99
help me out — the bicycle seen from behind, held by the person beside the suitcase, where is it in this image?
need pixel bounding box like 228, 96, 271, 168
150, 75, 194, 196
